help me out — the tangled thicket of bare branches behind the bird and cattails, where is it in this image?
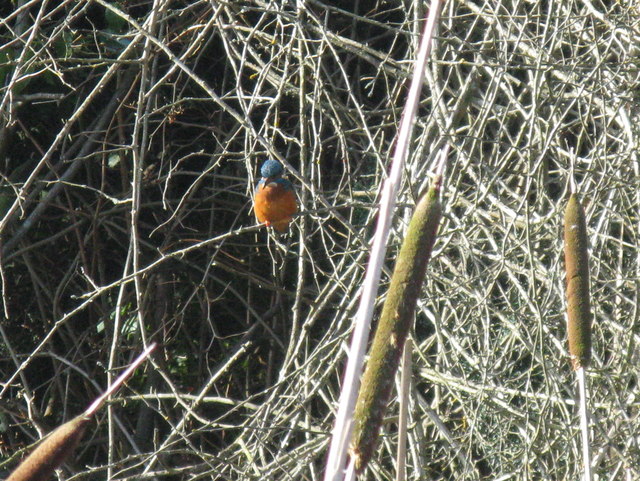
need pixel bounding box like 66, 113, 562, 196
0, 0, 640, 481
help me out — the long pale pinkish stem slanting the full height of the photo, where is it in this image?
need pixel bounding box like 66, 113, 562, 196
324, 0, 441, 481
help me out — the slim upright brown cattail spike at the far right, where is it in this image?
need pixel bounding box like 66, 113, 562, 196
564, 194, 591, 370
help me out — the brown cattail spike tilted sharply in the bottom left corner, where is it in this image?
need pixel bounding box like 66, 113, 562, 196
6, 415, 90, 481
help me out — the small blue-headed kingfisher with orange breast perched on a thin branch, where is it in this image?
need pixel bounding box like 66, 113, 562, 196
254, 159, 298, 232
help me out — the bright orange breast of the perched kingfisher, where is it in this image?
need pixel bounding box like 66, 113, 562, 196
254, 182, 298, 232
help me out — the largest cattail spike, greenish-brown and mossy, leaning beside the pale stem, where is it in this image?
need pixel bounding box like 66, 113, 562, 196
349, 177, 442, 473
